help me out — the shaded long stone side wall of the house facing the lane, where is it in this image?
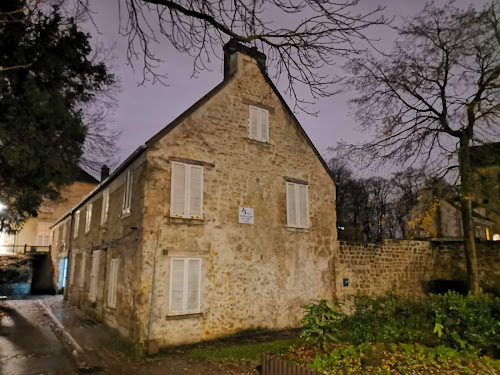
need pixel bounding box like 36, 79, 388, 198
53, 156, 145, 338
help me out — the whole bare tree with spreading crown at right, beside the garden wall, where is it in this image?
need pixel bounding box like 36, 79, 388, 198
341, 1, 500, 293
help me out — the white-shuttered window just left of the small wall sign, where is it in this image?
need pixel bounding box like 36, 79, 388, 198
170, 161, 203, 219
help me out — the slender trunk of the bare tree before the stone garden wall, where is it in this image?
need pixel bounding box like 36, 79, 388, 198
458, 131, 479, 294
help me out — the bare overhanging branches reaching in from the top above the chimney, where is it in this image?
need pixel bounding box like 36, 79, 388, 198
78, 0, 387, 113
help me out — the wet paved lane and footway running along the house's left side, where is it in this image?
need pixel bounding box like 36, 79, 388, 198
0, 300, 259, 375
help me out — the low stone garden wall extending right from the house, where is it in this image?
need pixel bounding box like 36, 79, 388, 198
335, 240, 500, 297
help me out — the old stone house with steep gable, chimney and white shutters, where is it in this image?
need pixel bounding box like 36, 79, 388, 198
53, 41, 337, 346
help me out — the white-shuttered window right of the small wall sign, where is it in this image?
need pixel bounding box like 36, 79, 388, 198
286, 182, 309, 228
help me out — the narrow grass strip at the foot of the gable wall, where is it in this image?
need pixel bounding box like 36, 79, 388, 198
189, 338, 304, 366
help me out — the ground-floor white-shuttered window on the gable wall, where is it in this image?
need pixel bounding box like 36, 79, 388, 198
169, 258, 201, 315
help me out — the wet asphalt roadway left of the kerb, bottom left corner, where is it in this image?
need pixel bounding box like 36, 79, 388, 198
0, 301, 77, 375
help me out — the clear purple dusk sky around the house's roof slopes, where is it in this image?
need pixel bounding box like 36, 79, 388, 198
87, 0, 486, 175
